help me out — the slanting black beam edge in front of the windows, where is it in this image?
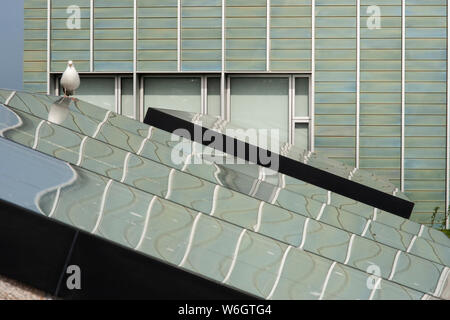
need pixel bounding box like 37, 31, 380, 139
144, 108, 414, 219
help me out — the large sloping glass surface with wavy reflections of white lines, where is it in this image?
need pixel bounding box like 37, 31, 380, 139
0, 90, 450, 299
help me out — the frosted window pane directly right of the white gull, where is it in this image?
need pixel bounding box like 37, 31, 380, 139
74, 77, 116, 111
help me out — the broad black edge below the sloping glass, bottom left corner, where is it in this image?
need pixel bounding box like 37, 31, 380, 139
0, 199, 255, 300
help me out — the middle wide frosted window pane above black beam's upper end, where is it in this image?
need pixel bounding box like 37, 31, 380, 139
144, 77, 201, 113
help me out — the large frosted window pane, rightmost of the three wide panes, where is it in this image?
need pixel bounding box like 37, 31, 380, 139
230, 77, 289, 142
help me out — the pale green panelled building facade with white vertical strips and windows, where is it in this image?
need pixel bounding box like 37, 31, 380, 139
24, 0, 449, 223
